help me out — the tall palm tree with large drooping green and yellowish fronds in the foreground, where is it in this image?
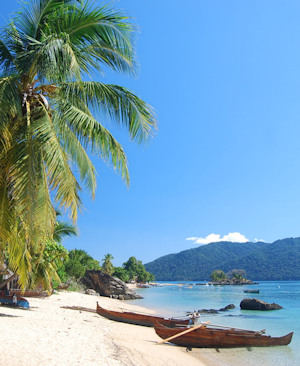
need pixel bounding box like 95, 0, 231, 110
0, 0, 156, 286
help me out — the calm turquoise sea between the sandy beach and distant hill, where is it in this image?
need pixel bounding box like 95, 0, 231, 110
127, 281, 300, 366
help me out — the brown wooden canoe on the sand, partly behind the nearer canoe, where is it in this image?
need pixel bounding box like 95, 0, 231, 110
96, 302, 189, 327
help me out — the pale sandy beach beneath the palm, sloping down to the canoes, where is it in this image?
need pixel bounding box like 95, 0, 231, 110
0, 292, 212, 366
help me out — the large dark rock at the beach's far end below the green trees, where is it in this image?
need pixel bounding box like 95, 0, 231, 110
81, 270, 142, 300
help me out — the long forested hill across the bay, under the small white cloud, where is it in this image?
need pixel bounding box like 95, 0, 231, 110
145, 238, 300, 281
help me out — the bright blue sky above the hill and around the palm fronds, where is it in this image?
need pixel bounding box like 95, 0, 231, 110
0, 0, 300, 265
